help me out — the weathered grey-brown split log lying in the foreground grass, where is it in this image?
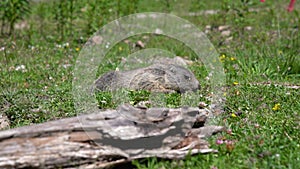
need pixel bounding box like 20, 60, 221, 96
0, 105, 224, 168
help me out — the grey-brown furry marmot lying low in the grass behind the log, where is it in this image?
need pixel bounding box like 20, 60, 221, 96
95, 63, 200, 93
